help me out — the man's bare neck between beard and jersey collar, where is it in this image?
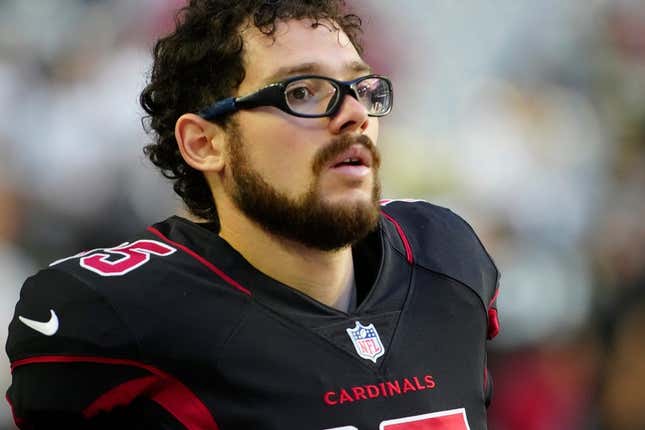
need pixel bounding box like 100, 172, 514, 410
218, 198, 354, 310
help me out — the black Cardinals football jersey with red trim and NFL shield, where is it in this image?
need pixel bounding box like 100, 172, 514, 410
7, 201, 499, 430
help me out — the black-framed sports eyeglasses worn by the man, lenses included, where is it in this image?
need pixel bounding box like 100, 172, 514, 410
199, 75, 393, 120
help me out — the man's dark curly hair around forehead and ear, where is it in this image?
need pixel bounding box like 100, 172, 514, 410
139, 0, 362, 221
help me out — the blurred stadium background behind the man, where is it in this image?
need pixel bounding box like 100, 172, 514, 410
0, 0, 645, 430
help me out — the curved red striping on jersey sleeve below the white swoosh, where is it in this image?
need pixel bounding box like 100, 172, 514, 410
11, 355, 219, 430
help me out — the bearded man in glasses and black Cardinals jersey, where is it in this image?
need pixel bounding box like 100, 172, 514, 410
7, 0, 498, 430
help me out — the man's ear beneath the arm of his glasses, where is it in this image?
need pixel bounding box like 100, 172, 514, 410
175, 113, 225, 172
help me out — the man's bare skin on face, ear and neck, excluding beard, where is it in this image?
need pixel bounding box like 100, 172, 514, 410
175, 20, 378, 307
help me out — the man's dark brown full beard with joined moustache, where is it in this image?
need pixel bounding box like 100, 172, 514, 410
225, 123, 381, 251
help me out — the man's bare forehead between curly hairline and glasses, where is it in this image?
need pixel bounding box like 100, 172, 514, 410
240, 19, 368, 91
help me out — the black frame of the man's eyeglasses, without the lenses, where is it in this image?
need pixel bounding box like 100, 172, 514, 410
198, 74, 394, 120
